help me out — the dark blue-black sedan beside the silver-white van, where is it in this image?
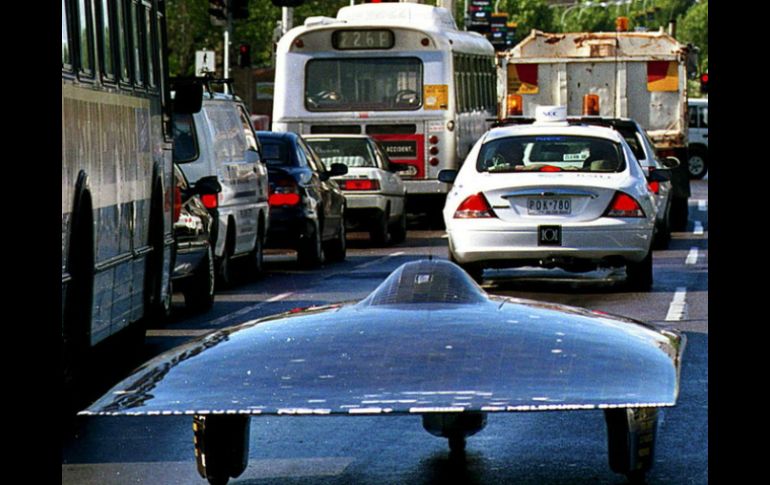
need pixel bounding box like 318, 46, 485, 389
257, 131, 348, 267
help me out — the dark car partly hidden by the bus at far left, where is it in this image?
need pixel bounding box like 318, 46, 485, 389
171, 164, 222, 312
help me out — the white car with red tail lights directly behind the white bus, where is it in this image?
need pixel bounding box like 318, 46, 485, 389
303, 135, 408, 245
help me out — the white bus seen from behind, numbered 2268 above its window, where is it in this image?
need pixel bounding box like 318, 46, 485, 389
273, 3, 497, 218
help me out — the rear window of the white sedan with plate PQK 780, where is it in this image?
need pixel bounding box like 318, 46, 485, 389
476, 135, 625, 173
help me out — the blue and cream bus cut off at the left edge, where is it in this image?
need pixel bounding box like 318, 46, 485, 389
61, 0, 183, 384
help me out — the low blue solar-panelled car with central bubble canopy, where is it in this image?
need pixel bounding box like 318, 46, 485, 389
81, 260, 685, 483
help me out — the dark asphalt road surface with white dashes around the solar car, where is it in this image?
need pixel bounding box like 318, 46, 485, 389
62, 180, 708, 485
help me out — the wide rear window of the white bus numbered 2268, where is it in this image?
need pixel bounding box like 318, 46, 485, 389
305, 57, 422, 111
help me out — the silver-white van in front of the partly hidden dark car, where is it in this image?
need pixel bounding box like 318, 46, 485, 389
174, 93, 269, 286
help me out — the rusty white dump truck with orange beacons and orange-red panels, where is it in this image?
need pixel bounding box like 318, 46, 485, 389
498, 29, 697, 230
